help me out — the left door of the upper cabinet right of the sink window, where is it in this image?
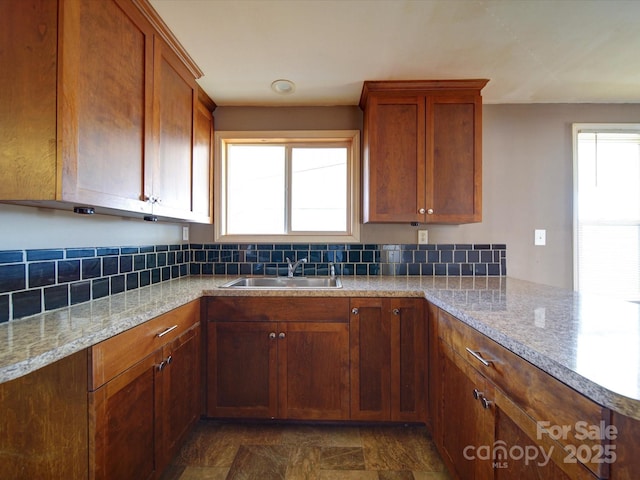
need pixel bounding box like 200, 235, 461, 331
363, 95, 426, 223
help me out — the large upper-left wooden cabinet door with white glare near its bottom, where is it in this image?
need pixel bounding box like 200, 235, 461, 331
57, 0, 153, 212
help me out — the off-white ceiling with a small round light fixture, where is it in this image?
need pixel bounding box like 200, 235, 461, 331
150, 0, 640, 106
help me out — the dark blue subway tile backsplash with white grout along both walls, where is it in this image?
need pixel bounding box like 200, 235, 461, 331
0, 243, 506, 322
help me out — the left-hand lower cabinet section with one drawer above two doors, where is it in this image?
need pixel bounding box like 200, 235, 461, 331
89, 301, 201, 480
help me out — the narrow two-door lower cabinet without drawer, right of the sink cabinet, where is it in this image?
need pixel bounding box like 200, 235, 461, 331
350, 298, 427, 422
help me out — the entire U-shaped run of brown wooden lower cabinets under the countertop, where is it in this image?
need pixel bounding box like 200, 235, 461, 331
7, 297, 640, 480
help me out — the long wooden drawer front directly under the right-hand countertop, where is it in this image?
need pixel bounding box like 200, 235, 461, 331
438, 311, 611, 476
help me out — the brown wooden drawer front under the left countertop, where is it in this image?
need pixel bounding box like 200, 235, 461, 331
89, 300, 200, 390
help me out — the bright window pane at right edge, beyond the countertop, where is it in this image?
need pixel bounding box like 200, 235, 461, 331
575, 130, 640, 301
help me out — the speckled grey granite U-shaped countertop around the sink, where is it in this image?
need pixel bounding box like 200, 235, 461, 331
0, 276, 640, 420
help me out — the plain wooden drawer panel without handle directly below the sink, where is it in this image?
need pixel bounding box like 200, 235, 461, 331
207, 297, 349, 322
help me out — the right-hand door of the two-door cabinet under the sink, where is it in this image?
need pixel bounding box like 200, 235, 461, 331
278, 322, 349, 420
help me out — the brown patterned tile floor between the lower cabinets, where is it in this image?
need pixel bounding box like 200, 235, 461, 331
162, 420, 450, 480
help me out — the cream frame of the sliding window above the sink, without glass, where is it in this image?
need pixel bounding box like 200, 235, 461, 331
214, 130, 360, 243
